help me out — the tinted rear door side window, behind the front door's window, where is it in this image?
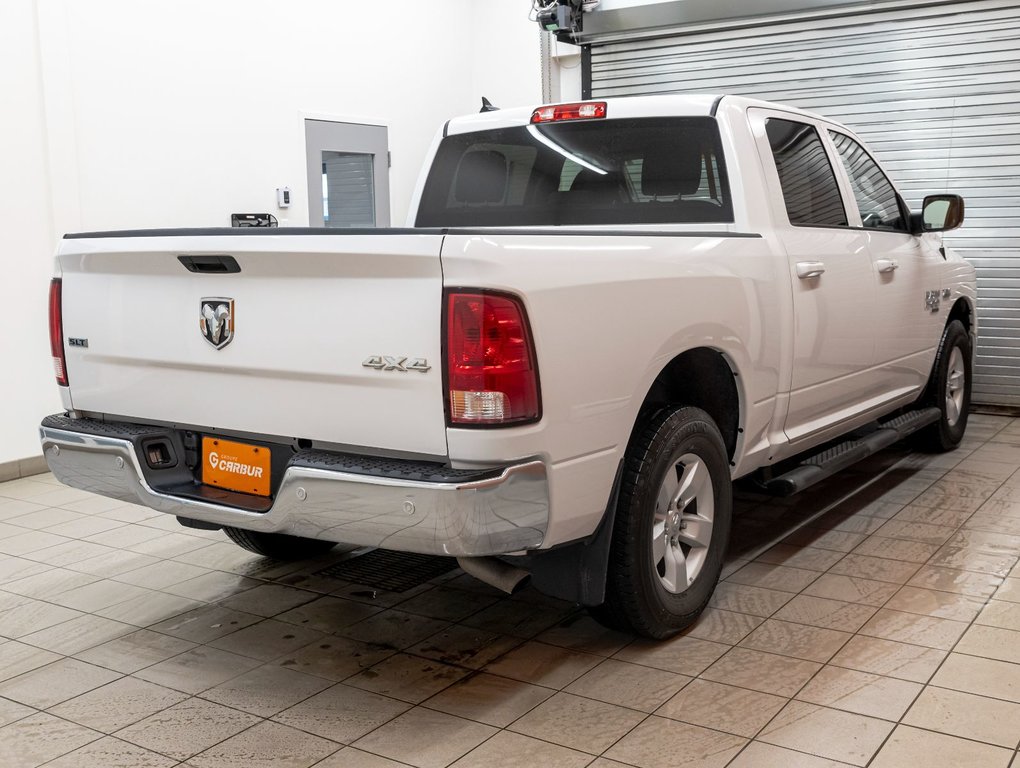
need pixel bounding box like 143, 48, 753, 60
765, 117, 849, 226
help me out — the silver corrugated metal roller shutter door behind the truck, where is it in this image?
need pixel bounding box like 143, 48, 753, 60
591, 0, 1020, 406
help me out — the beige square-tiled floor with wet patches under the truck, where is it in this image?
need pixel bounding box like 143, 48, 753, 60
0, 415, 1020, 768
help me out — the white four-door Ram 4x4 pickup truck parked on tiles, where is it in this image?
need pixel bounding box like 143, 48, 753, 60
41, 96, 976, 637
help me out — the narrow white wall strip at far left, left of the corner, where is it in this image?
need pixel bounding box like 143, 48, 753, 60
0, 0, 60, 464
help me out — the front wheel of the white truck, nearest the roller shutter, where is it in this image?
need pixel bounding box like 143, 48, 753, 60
915, 320, 971, 453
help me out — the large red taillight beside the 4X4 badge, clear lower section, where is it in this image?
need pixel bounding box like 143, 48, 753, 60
446, 293, 541, 425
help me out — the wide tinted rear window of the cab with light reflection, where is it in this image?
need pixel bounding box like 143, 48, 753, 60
415, 117, 733, 226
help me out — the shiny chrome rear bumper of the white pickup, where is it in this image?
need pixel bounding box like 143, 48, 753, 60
40, 420, 549, 557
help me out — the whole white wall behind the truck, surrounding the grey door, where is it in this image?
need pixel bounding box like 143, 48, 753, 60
0, 0, 542, 463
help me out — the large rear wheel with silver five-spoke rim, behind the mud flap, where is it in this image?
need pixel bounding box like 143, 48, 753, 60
592, 407, 732, 639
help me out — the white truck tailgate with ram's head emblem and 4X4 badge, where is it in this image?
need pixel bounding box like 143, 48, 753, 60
58, 229, 447, 457
